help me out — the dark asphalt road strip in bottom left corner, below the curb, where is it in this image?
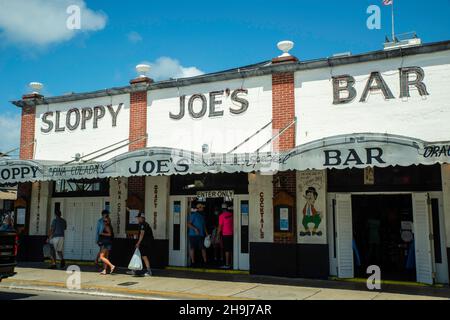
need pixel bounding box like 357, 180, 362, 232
0, 289, 134, 301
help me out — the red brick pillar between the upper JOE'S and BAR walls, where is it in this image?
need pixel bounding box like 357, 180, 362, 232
272, 72, 297, 243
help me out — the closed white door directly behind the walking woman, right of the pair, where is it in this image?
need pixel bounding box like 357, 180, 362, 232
81, 198, 103, 260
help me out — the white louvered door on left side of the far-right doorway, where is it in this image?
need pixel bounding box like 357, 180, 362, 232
336, 194, 354, 278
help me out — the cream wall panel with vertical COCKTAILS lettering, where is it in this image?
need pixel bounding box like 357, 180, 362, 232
248, 173, 273, 242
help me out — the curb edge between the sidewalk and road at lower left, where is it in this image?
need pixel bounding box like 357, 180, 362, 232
0, 279, 252, 300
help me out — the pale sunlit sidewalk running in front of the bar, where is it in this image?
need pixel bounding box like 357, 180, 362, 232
0, 264, 450, 300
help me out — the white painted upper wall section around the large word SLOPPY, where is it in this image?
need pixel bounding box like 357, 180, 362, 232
35, 94, 130, 161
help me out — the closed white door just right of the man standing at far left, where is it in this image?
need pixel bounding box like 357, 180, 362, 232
61, 199, 83, 260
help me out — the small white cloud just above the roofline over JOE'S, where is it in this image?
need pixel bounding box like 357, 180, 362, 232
144, 57, 204, 80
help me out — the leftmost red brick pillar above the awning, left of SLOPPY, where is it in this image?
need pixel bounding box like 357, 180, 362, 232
20, 106, 36, 160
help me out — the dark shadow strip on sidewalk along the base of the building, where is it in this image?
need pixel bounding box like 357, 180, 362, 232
18, 262, 450, 299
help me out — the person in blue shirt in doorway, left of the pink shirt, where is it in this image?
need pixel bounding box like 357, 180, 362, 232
188, 203, 208, 266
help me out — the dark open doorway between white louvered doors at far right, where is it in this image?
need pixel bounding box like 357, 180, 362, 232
352, 194, 416, 281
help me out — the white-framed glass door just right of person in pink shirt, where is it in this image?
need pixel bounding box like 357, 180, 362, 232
233, 195, 250, 270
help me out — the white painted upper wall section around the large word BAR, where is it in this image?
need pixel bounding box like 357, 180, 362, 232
295, 51, 450, 145
